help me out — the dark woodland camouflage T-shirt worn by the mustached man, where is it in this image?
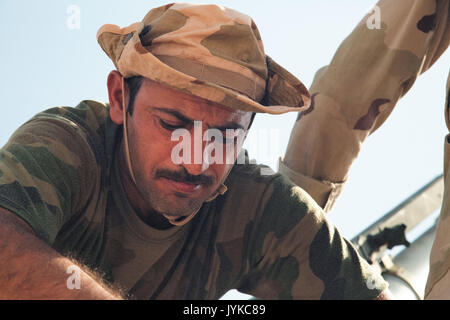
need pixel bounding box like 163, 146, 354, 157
0, 101, 387, 299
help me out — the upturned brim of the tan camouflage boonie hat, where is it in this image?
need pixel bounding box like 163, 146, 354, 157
97, 23, 311, 114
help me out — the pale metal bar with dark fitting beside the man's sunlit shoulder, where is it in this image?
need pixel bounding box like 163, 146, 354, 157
352, 175, 444, 299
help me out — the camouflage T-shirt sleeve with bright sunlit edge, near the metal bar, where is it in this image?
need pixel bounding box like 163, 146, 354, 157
238, 176, 387, 300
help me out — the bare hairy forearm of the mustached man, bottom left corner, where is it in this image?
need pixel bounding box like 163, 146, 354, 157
0, 208, 120, 300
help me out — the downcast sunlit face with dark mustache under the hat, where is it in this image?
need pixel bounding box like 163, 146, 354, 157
122, 79, 251, 216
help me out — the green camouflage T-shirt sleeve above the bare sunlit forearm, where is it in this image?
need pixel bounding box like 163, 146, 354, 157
0, 108, 96, 245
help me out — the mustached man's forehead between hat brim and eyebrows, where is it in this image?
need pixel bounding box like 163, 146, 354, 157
136, 78, 251, 122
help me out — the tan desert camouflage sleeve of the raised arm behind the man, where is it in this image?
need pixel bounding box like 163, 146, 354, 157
280, 0, 450, 212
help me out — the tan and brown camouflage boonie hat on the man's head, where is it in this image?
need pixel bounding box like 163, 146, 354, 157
97, 3, 310, 114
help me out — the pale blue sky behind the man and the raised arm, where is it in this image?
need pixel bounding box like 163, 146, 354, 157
0, 0, 450, 238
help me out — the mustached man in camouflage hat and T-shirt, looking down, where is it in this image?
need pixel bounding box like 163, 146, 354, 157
0, 4, 389, 299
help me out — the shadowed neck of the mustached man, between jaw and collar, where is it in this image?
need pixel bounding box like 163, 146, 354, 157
117, 140, 172, 230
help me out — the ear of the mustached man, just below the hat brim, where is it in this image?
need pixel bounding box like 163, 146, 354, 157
107, 70, 128, 125
